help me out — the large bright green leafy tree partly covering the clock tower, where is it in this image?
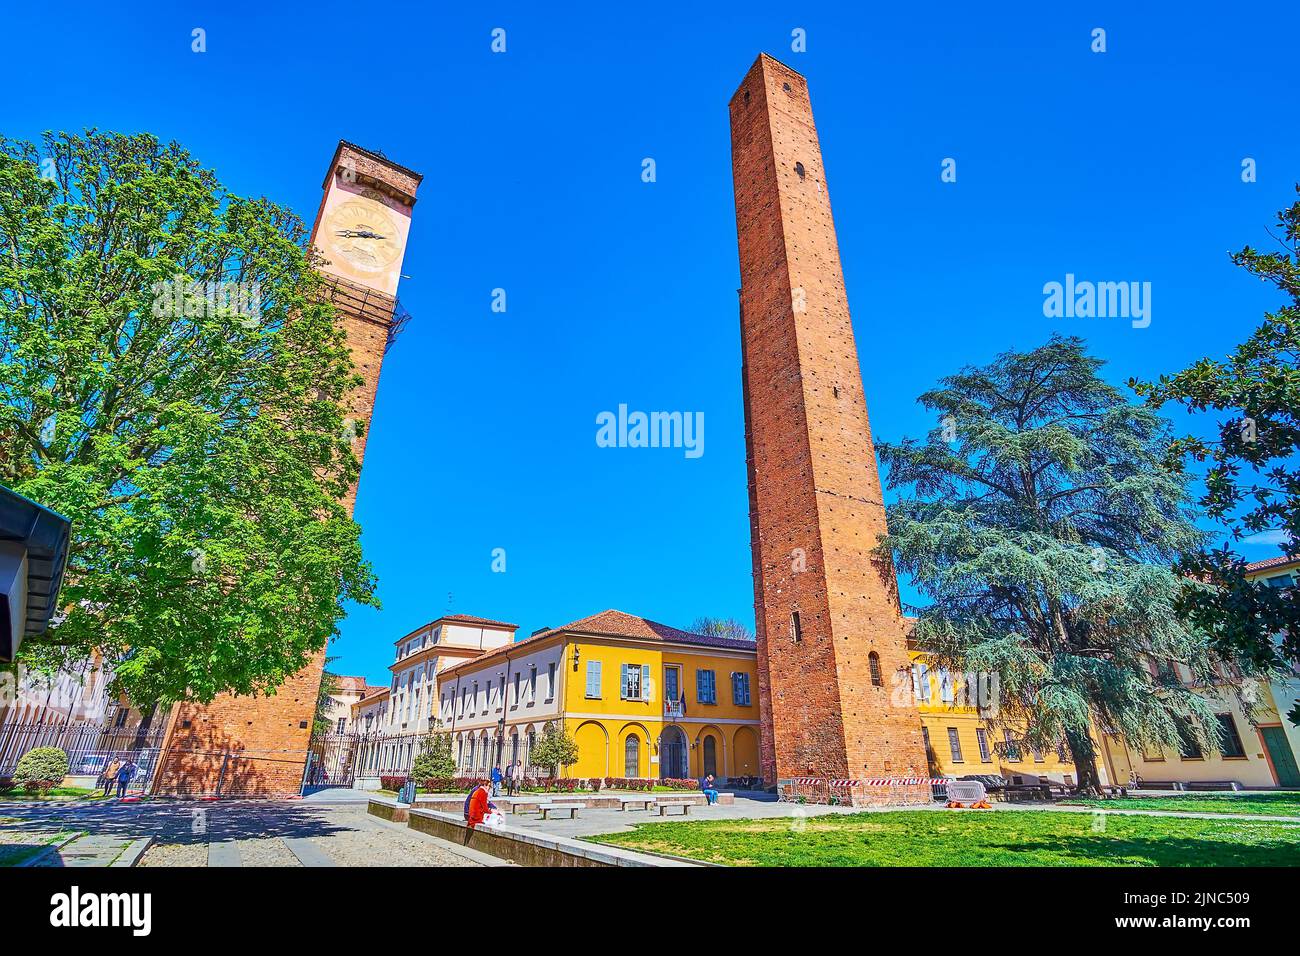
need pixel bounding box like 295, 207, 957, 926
0, 131, 374, 704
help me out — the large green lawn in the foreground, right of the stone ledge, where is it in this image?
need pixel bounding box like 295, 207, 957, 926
589, 810, 1300, 866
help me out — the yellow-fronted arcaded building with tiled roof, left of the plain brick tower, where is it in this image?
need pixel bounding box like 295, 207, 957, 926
439, 610, 761, 780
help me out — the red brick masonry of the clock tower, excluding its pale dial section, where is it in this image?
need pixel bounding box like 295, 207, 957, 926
153, 146, 419, 797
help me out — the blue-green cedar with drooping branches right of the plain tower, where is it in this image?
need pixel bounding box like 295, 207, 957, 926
879, 338, 1248, 788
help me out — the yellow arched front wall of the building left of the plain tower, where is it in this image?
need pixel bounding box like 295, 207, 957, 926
563, 637, 759, 779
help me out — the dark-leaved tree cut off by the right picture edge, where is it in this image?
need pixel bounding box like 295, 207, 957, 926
1132, 186, 1300, 723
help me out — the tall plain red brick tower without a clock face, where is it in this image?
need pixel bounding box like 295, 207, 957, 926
731, 55, 930, 803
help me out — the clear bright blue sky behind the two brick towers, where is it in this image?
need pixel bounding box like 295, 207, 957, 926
0, 3, 1300, 680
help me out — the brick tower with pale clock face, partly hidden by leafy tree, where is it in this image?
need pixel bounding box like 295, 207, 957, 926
155, 142, 421, 797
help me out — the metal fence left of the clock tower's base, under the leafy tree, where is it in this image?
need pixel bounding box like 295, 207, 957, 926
0, 722, 166, 790
